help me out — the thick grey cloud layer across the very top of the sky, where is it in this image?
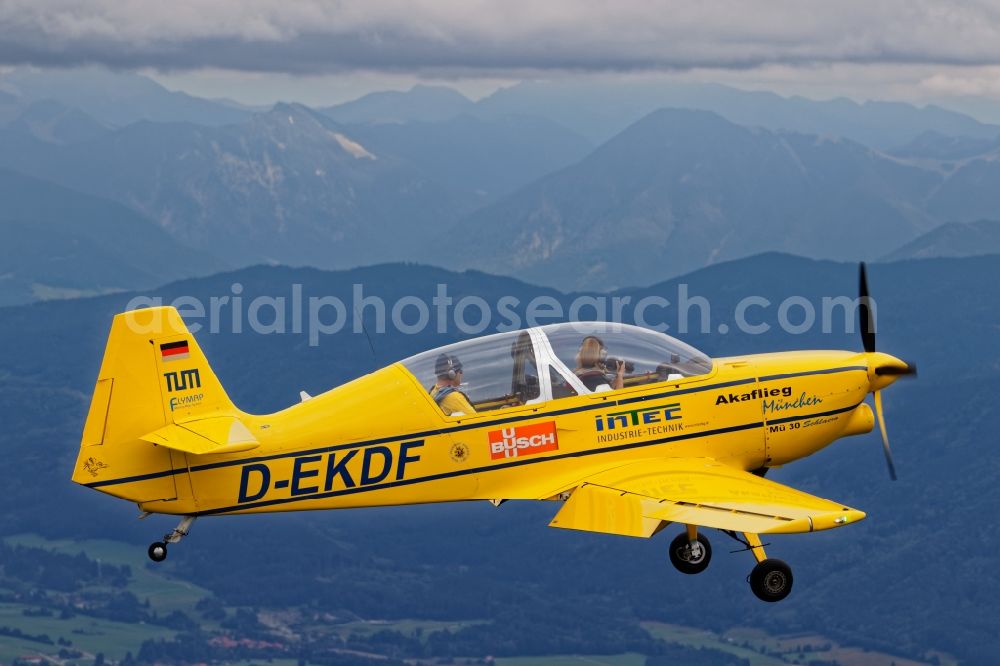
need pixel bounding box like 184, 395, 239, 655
0, 0, 1000, 75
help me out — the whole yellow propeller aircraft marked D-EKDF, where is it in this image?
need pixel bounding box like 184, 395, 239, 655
73, 265, 915, 601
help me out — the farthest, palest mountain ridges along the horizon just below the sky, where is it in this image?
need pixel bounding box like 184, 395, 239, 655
9, 67, 1000, 150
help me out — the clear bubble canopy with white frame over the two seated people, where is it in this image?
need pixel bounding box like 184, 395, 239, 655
402, 322, 712, 412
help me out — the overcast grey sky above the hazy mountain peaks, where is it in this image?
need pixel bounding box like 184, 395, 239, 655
0, 0, 1000, 115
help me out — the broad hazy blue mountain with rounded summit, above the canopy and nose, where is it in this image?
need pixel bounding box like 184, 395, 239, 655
436, 110, 954, 289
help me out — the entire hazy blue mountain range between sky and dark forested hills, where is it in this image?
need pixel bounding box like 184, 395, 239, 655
0, 70, 1000, 290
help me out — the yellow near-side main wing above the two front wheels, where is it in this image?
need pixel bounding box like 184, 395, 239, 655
549, 458, 865, 537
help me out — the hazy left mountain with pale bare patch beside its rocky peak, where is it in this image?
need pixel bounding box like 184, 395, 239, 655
0, 98, 589, 267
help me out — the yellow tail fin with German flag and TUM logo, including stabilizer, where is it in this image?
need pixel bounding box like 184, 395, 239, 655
73, 307, 256, 492
